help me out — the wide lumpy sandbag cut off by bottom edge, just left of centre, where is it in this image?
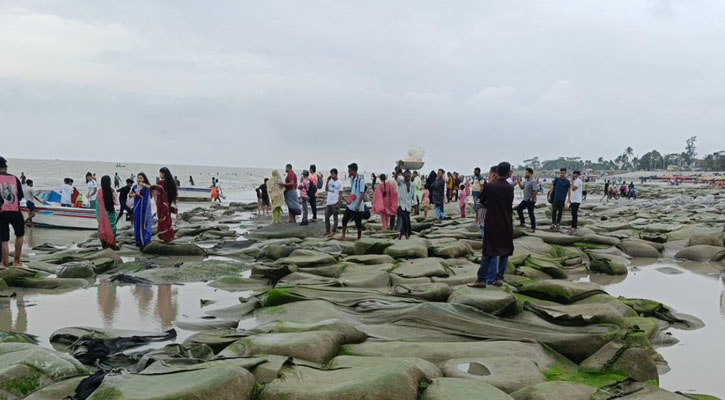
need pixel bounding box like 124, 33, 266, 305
259, 363, 424, 400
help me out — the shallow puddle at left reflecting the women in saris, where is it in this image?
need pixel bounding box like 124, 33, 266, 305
0, 282, 256, 346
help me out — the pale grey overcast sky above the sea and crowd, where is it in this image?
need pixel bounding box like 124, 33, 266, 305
0, 0, 725, 170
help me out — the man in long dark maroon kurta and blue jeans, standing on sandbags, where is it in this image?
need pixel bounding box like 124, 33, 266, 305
468, 162, 514, 288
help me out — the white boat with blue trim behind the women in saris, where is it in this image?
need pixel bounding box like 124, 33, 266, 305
20, 205, 130, 230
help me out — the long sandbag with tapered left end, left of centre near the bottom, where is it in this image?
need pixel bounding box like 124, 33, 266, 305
219, 331, 345, 364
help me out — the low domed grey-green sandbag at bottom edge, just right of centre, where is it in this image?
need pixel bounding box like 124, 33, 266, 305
420, 378, 512, 400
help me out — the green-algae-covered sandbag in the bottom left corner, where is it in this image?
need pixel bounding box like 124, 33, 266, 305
0, 343, 88, 399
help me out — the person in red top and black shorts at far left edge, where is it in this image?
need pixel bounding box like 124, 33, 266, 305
0, 157, 25, 270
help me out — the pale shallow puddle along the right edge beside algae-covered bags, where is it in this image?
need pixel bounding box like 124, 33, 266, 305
591, 260, 725, 397
